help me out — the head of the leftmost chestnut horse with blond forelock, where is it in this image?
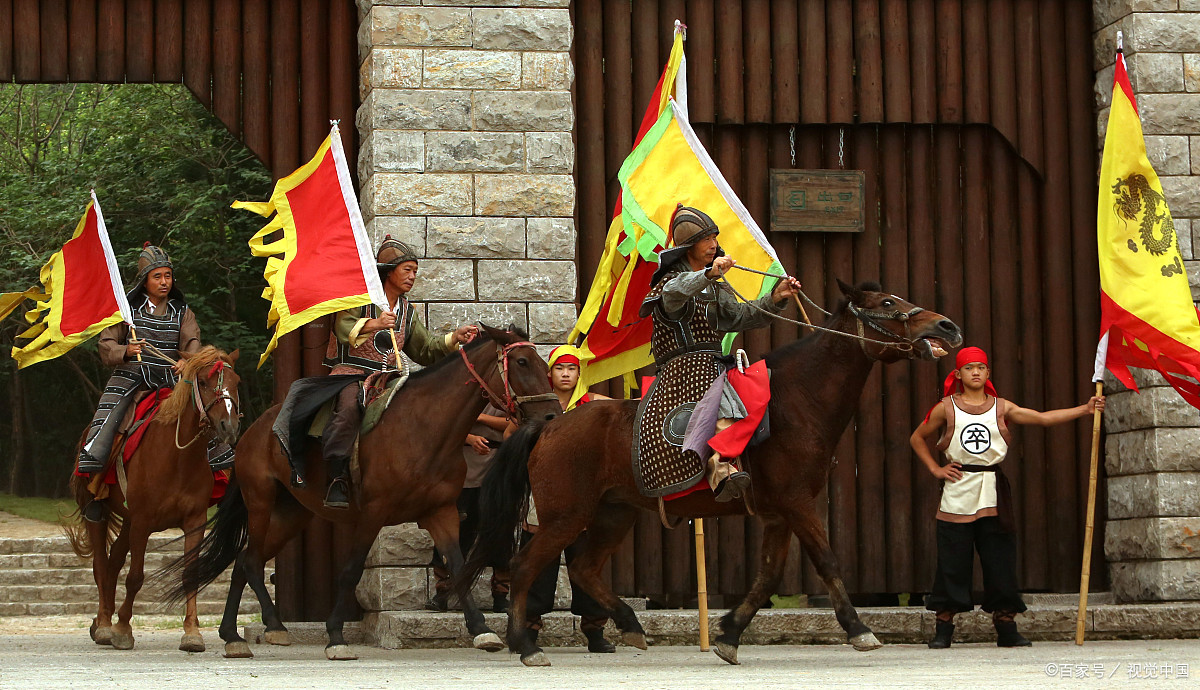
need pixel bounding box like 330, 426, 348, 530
168, 346, 241, 445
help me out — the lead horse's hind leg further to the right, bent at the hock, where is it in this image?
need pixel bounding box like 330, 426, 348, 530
554, 503, 646, 649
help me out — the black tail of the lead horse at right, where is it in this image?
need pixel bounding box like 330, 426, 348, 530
454, 422, 545, 599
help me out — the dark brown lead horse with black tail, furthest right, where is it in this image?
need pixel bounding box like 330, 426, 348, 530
456, 281, 962, 666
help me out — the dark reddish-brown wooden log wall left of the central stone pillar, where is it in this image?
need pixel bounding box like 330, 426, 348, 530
0, 0, 359, 620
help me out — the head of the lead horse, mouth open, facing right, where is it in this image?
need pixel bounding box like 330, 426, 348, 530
838, 280, 962, 362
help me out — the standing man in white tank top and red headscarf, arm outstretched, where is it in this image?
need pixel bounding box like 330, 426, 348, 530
908, 347, 1104, 649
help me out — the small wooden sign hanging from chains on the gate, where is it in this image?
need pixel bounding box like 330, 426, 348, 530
770, 168, 865, 233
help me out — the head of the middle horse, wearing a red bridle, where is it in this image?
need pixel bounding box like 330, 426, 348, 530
479, 322, 563, 421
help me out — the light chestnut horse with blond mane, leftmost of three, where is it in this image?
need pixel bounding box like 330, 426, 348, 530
67, 346, 240, 652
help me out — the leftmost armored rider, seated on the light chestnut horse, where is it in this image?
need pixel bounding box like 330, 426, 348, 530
78, 242, 234, 522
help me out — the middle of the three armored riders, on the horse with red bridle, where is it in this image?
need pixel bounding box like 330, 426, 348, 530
323, 235, 479, 509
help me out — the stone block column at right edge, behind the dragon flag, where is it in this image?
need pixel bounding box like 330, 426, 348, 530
1093, 0, 1200, 601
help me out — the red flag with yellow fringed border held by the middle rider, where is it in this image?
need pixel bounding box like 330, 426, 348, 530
233, 124, 388, 366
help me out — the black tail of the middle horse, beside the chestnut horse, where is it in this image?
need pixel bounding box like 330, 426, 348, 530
152, 473, 250, 606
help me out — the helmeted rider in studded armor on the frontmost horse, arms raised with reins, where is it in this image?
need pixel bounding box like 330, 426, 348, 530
640, 205, 800, 502
